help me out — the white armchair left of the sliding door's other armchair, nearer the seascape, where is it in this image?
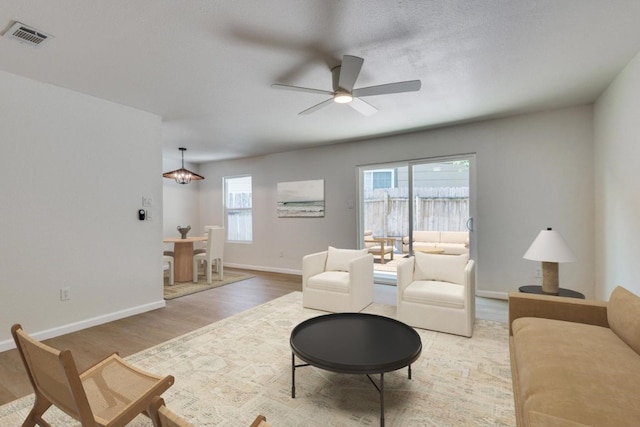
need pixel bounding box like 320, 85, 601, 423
302, 246, 373, 313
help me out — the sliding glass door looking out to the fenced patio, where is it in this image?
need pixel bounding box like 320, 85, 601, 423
359, 155, 475, 283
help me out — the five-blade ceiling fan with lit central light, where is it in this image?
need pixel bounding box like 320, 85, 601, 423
271, 55, 421, 116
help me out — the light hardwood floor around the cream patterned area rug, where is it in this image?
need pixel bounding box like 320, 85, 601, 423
0, 268, 507, 405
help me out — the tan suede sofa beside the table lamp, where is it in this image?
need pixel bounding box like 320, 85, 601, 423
509, 287, 640, 427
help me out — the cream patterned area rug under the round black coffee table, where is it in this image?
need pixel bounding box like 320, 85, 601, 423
0, 292, 515, 427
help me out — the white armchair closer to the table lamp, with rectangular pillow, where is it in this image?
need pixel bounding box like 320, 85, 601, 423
397, 252, 476, 337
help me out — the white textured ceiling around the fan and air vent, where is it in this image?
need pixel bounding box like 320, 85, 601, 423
0, 0, 640, 162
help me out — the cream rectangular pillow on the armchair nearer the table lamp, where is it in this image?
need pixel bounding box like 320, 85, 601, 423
413, 252, 469, 283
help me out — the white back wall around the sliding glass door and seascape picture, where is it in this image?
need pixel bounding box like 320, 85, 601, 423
192, 105, 594, 297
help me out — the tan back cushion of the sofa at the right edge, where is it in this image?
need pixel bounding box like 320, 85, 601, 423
607, 286, 640, 355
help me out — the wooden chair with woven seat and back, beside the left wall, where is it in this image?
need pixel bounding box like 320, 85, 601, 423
11, 324, 174, 427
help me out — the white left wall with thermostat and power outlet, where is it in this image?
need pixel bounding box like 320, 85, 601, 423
0, 72, 164, 351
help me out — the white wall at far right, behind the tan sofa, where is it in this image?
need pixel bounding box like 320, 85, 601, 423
594, 50, 640, 300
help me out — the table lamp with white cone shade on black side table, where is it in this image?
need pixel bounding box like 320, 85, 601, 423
523, 228, 576, 295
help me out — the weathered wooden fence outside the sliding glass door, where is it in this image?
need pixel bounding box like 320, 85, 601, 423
364, 187, 469, 236
